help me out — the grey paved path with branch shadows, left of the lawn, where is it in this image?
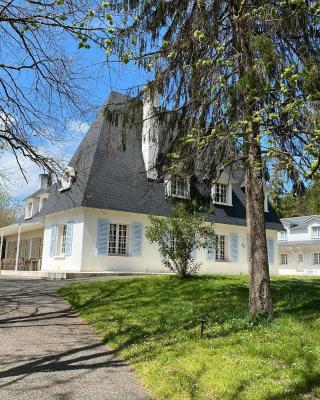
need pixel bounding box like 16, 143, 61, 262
0, 278, 147, 400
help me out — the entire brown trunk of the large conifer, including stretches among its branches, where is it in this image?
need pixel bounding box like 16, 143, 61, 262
231, 0, 272, 316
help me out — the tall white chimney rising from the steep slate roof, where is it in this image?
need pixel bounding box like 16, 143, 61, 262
142, 93, 160, 180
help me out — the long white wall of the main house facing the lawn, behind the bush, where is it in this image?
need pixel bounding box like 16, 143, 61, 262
81, 209, 278, 275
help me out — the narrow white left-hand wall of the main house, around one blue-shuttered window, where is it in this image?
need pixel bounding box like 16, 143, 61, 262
41, 208, 84, 272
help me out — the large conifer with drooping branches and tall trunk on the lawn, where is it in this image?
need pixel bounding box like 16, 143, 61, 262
107, 0, 320, 315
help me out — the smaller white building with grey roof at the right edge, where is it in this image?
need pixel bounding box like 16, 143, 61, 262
279, 215, 320, 275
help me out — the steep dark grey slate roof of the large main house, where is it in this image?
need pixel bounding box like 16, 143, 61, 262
25, 92, 283, 230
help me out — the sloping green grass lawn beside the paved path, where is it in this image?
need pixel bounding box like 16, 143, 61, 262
60, 275, 320, 400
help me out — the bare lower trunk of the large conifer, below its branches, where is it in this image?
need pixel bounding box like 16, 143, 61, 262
245, 127, 272, 316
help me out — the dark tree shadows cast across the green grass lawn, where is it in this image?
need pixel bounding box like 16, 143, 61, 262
60, 276, 320, 400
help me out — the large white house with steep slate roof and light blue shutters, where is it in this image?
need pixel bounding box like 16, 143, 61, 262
0, 92, 283, 274
